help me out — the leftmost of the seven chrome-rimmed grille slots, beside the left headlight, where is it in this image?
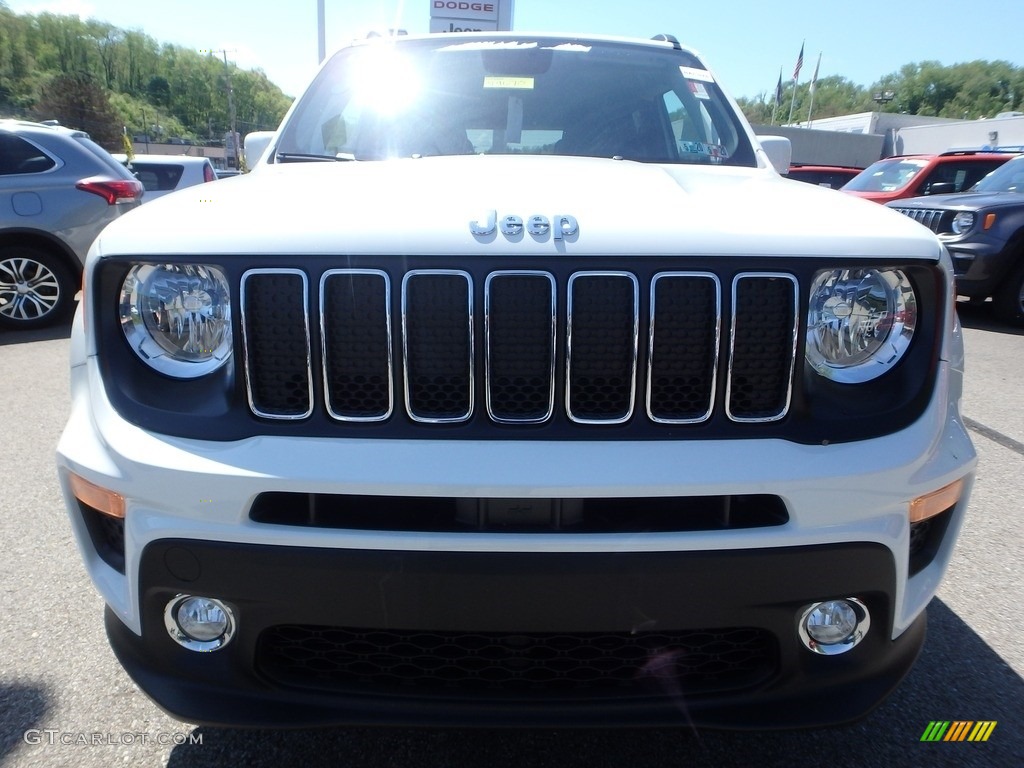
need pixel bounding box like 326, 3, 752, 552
241, 269, 312, 419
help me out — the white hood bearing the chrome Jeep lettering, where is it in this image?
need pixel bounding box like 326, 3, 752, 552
97, 156, 940, 259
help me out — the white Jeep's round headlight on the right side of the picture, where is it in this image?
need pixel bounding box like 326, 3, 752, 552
807, 269, 918, 384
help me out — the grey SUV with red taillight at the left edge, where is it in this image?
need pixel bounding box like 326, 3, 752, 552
0, 120, 142, 329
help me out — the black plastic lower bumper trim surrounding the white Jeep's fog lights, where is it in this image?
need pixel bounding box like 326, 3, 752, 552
106, 540, 925, 728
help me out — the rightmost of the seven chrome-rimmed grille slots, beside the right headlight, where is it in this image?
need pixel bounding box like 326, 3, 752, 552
726, 272, 800, 422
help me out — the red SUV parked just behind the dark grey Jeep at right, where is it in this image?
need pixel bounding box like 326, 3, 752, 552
842, 152, 1013, 203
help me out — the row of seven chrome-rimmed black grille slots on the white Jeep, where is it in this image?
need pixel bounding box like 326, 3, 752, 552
242, 269, 799, 425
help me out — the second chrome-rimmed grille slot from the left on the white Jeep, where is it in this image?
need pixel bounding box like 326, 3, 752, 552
321, 269, 394, 421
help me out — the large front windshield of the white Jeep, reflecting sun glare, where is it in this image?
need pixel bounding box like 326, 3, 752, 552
275, 36, 756, 166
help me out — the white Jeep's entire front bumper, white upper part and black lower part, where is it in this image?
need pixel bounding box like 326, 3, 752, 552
58, 352, 975, 728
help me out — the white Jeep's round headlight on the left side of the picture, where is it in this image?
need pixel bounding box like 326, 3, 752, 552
120, 264, 231, 379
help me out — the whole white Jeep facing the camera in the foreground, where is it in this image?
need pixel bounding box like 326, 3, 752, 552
57, 32, 976, 729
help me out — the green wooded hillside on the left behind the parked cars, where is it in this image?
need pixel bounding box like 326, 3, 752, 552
0, 8, 291, 148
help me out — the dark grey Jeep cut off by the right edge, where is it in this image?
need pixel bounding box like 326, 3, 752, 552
888, 156, 1024, 326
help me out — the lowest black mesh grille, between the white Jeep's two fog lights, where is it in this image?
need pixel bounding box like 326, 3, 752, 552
257, 625, 778, 694
